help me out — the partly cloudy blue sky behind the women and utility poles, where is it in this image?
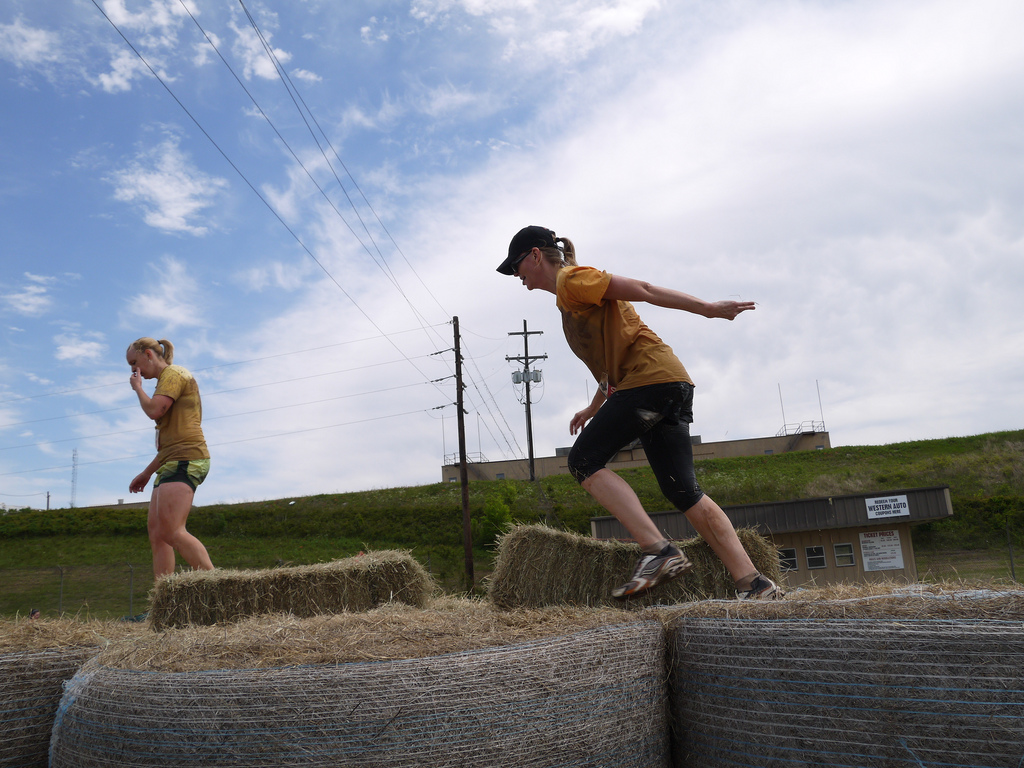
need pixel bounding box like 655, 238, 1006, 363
0, 0, 1024, 507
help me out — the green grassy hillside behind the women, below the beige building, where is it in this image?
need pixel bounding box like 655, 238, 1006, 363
0, 430, 1024, 615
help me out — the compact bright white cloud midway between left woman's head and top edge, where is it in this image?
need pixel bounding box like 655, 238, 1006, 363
110, 135, 228, 236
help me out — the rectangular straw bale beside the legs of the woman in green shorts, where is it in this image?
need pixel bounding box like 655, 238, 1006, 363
150, 551, 435, 630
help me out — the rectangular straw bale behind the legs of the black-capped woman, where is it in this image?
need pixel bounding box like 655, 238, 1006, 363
487, 525, 780, 608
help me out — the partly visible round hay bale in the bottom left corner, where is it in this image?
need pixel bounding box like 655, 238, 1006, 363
0, 618, 148, 768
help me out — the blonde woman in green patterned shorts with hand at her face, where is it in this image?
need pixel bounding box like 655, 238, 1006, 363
126, 337, 213, 579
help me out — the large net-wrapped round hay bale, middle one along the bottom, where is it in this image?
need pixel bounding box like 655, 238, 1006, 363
50, 611, 669, 768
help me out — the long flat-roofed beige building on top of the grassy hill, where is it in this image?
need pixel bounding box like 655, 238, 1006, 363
441, 431, 831, 482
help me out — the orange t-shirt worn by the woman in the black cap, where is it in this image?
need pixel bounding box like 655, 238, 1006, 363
555, 266, 693, 394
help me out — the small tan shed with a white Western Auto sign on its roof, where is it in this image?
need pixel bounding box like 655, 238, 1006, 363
590, 485, 953, 587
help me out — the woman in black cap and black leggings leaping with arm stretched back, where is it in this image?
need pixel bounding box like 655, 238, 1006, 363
498, 226, 782, 599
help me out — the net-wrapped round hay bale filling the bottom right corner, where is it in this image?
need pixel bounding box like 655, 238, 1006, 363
670, 616, 1024, 768
